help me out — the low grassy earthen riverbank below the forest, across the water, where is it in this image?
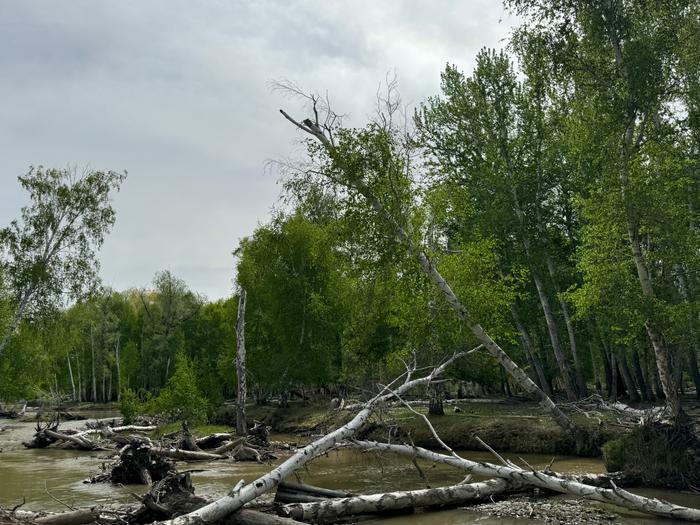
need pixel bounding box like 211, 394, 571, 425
231, 399, 628, 457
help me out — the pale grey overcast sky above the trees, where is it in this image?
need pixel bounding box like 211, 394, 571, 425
0, 0, 513, 299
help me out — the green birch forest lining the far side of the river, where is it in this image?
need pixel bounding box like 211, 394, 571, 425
0, 0, 700, 523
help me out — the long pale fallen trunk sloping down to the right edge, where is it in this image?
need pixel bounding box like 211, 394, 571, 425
344, 441, 700, 522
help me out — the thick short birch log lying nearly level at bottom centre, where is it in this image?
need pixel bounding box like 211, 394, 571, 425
280, 479, 520, 523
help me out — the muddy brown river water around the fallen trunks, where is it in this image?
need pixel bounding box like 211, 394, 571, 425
0, 420, 700, 525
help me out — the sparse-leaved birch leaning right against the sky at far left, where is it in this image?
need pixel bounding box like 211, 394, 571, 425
0, 166, 126, 355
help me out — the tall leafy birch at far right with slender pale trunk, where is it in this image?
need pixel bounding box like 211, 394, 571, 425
507, 0, 700, 420
